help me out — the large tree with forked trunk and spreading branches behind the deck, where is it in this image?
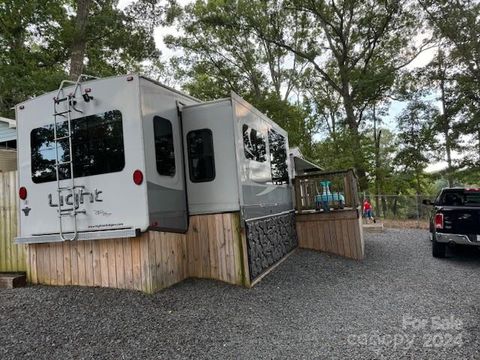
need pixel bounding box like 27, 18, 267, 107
248, 0, 432, 188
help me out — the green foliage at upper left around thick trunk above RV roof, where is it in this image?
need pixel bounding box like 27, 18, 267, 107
0, 0, 159, 117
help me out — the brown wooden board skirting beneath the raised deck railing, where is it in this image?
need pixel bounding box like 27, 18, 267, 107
296, 209, 364, 260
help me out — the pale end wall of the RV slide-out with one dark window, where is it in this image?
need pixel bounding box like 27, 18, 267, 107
182, 99, 240, 215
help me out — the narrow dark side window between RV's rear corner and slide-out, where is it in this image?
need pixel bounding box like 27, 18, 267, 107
153, 116, 175, 176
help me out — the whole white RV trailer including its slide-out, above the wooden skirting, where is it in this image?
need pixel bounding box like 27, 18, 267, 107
16, 75, 293, 243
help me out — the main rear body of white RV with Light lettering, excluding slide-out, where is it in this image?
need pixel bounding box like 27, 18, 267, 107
16, 75, 198, 243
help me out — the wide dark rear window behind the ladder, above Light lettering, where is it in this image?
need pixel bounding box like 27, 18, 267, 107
30, 110, 125, 183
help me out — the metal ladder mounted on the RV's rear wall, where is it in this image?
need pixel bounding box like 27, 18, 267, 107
53, 75, 97, 241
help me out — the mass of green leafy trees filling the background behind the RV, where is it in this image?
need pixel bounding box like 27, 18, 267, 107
0, 0, 480, 194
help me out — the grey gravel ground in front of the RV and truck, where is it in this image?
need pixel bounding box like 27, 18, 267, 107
0, 230, 480, 359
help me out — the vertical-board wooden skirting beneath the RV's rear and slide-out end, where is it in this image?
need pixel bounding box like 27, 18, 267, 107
28, 213, 250, 293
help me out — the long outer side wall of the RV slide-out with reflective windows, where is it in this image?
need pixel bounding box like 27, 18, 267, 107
232, 95, 293, 220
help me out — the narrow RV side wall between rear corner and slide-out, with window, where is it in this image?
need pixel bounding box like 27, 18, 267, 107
140, 78, 197, 232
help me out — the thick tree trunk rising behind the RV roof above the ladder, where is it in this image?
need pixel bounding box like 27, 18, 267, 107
70, 0, 91, 80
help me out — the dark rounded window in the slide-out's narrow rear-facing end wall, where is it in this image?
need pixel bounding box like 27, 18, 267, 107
187, 129, 215, 182
